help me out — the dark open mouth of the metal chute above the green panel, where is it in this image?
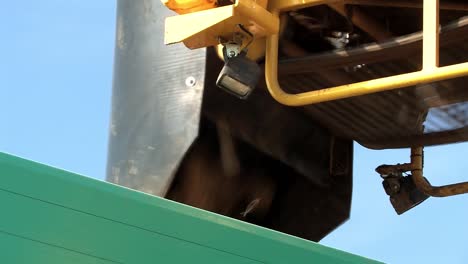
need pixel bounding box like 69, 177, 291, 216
167, 52, 353, 241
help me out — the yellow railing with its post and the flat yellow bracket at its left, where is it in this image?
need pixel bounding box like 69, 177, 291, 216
165, 0, 468, 106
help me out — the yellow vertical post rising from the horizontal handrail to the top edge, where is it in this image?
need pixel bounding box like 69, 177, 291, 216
423, 0, 439, 70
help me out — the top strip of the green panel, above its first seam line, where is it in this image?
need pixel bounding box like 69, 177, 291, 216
0, 153, 376, 263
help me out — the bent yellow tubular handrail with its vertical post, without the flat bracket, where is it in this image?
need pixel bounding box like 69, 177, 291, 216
265, 0, 468, 106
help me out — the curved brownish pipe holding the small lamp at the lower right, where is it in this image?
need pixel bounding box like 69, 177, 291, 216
411, 147, 468, 197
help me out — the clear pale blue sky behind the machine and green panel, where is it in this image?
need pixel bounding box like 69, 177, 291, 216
0, 0, 468, 263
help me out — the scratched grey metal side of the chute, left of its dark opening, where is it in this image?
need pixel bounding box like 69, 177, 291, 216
107, 0, 206, 196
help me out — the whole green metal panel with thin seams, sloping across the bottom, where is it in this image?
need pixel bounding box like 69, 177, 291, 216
0, 153, 375, 264
